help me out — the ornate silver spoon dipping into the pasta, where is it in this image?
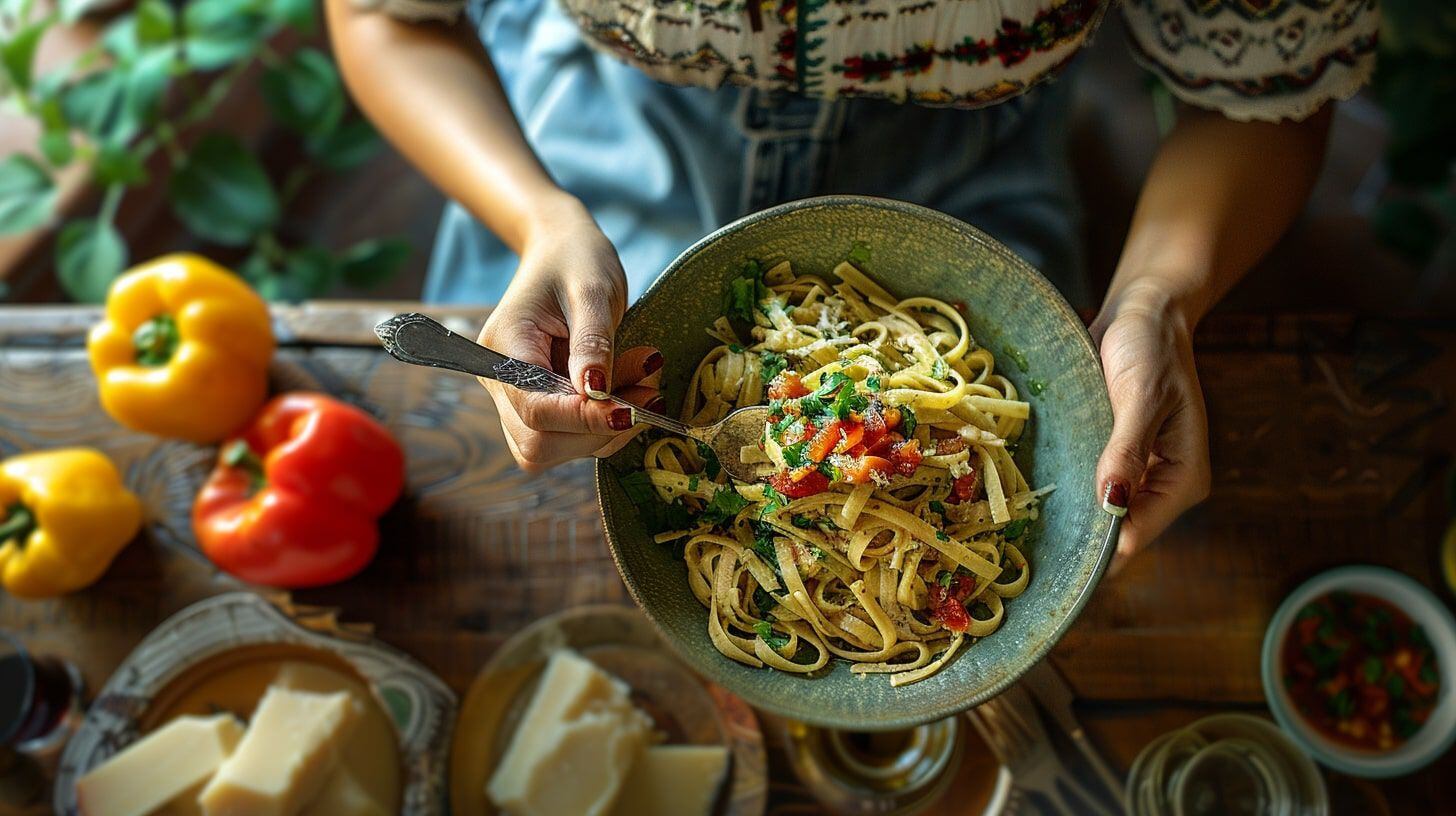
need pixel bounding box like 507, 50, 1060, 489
374, 312, 769, 482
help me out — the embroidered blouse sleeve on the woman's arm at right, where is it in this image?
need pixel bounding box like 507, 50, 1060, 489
1123, 0, 1380, 122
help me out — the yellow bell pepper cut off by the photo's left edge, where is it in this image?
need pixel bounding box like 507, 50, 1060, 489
0, 447, 141, 597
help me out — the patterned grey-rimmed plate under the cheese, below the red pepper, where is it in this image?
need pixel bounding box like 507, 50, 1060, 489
52, 592, 456, 816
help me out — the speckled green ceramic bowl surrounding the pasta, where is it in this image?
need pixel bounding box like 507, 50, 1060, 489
597, 197, 1115, 730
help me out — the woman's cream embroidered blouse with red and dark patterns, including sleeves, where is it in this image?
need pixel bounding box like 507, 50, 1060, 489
355, 0, 1380, 121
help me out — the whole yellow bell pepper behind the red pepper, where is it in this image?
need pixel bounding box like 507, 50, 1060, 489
87, 254, 274, 443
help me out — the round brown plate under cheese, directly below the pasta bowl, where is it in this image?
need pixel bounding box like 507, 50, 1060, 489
450, 606, 769, 816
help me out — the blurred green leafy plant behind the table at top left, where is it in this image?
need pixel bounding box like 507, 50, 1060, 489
0, 0, 409, 302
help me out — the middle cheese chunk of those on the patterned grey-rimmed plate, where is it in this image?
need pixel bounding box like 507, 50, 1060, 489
198, 686, 358, 816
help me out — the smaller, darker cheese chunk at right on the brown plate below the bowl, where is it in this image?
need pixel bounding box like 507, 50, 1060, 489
613, 745, 728, 816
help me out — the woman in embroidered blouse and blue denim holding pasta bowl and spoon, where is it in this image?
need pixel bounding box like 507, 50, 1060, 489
328, 0, 1379, 568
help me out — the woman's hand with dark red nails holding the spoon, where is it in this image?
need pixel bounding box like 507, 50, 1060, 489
480, 200, 662, 472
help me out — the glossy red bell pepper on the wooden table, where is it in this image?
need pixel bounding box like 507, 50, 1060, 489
192, 392, 405, 589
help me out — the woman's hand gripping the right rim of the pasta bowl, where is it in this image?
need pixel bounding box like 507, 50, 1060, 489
1091, 281, 1210, 574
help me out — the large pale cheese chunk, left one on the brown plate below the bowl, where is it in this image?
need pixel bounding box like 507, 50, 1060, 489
485, 650, 652, 816
